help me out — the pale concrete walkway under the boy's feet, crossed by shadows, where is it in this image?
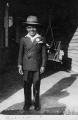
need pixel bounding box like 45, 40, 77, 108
0, 64, 78, 115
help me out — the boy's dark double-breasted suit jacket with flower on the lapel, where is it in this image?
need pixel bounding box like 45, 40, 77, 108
18, 33, 47, 71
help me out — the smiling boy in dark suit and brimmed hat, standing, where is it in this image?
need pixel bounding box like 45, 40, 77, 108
18, 16, 46, 111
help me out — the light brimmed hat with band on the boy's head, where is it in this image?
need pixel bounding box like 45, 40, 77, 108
24, 16, 40, 25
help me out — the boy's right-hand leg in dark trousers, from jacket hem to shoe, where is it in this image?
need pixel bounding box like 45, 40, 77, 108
33, 72, 40, 110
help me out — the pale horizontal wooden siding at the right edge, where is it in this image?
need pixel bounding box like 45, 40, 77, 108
68, 28, 78, 72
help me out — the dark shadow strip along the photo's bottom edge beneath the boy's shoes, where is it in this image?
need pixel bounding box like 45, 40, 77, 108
1, 107, 65, 115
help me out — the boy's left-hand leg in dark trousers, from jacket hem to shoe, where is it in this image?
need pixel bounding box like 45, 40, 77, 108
24, 71, 32, 110
